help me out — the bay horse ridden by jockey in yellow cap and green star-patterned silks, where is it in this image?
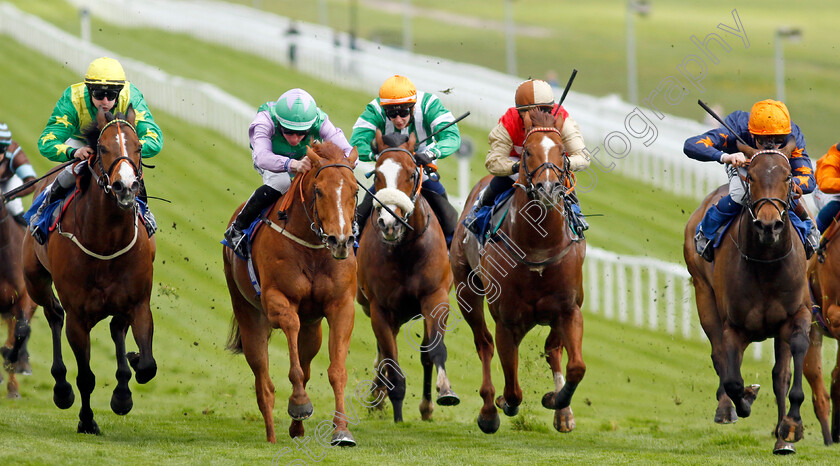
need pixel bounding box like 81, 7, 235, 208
23, 106, 157, 434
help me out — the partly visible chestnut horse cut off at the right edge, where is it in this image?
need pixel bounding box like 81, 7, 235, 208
804, 231, 840, 445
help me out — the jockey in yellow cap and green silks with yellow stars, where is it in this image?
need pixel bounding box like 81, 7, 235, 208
29, 57, 163, 244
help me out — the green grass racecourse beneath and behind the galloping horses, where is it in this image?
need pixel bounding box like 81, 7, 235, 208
0, 0, 837, 464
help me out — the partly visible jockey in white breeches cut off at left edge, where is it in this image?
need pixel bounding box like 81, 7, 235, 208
0, 122, 36, 226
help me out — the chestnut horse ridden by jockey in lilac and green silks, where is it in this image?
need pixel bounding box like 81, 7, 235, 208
223, 142, 358, 446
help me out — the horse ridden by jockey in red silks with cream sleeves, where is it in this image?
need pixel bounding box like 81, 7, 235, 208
451, 109, 586, 433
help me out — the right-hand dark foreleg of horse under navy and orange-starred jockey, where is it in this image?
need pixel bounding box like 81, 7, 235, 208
776, 314, 811, 442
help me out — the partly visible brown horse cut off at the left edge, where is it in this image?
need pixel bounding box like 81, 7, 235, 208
0, 191, 36, 399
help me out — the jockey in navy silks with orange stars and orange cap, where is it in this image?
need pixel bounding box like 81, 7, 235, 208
683, 99, 820, 262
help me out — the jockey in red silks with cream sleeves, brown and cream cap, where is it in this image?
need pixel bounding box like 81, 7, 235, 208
464, 79, 590, 236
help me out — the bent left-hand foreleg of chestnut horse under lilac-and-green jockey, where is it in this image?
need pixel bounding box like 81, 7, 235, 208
262, 287, 314, 426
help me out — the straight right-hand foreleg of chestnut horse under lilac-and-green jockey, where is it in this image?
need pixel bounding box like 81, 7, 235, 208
326, 294, 354, 447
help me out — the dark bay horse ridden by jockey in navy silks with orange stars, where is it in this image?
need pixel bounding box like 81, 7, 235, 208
683, 146, 811, 454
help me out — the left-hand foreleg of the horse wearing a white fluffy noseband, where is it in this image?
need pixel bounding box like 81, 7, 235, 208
370, 301, 406, 422
